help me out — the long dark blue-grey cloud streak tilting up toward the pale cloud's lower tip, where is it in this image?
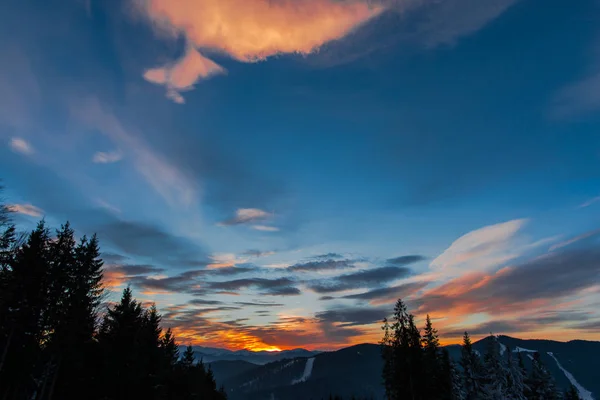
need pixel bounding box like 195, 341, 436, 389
309, 267, 411, 293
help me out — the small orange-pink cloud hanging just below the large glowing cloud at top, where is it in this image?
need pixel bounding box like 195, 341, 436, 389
144, 46, 225, 104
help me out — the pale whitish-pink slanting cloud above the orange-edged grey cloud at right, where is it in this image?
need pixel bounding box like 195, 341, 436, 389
431, 219, 527, 274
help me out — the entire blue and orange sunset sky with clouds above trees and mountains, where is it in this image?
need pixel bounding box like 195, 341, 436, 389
0, 0, 600, 350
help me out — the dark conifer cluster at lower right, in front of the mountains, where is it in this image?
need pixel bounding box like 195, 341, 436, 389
381, 300, 579, 400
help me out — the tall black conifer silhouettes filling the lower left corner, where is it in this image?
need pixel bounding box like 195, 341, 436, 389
0, 194, 226, 400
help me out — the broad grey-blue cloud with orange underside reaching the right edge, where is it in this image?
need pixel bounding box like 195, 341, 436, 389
419, 239, 600, 315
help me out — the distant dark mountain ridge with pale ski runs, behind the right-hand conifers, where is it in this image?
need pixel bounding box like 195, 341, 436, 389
211, 336, 600, 400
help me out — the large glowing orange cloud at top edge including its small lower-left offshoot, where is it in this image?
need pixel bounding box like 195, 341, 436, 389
138, 0, 383, 103
